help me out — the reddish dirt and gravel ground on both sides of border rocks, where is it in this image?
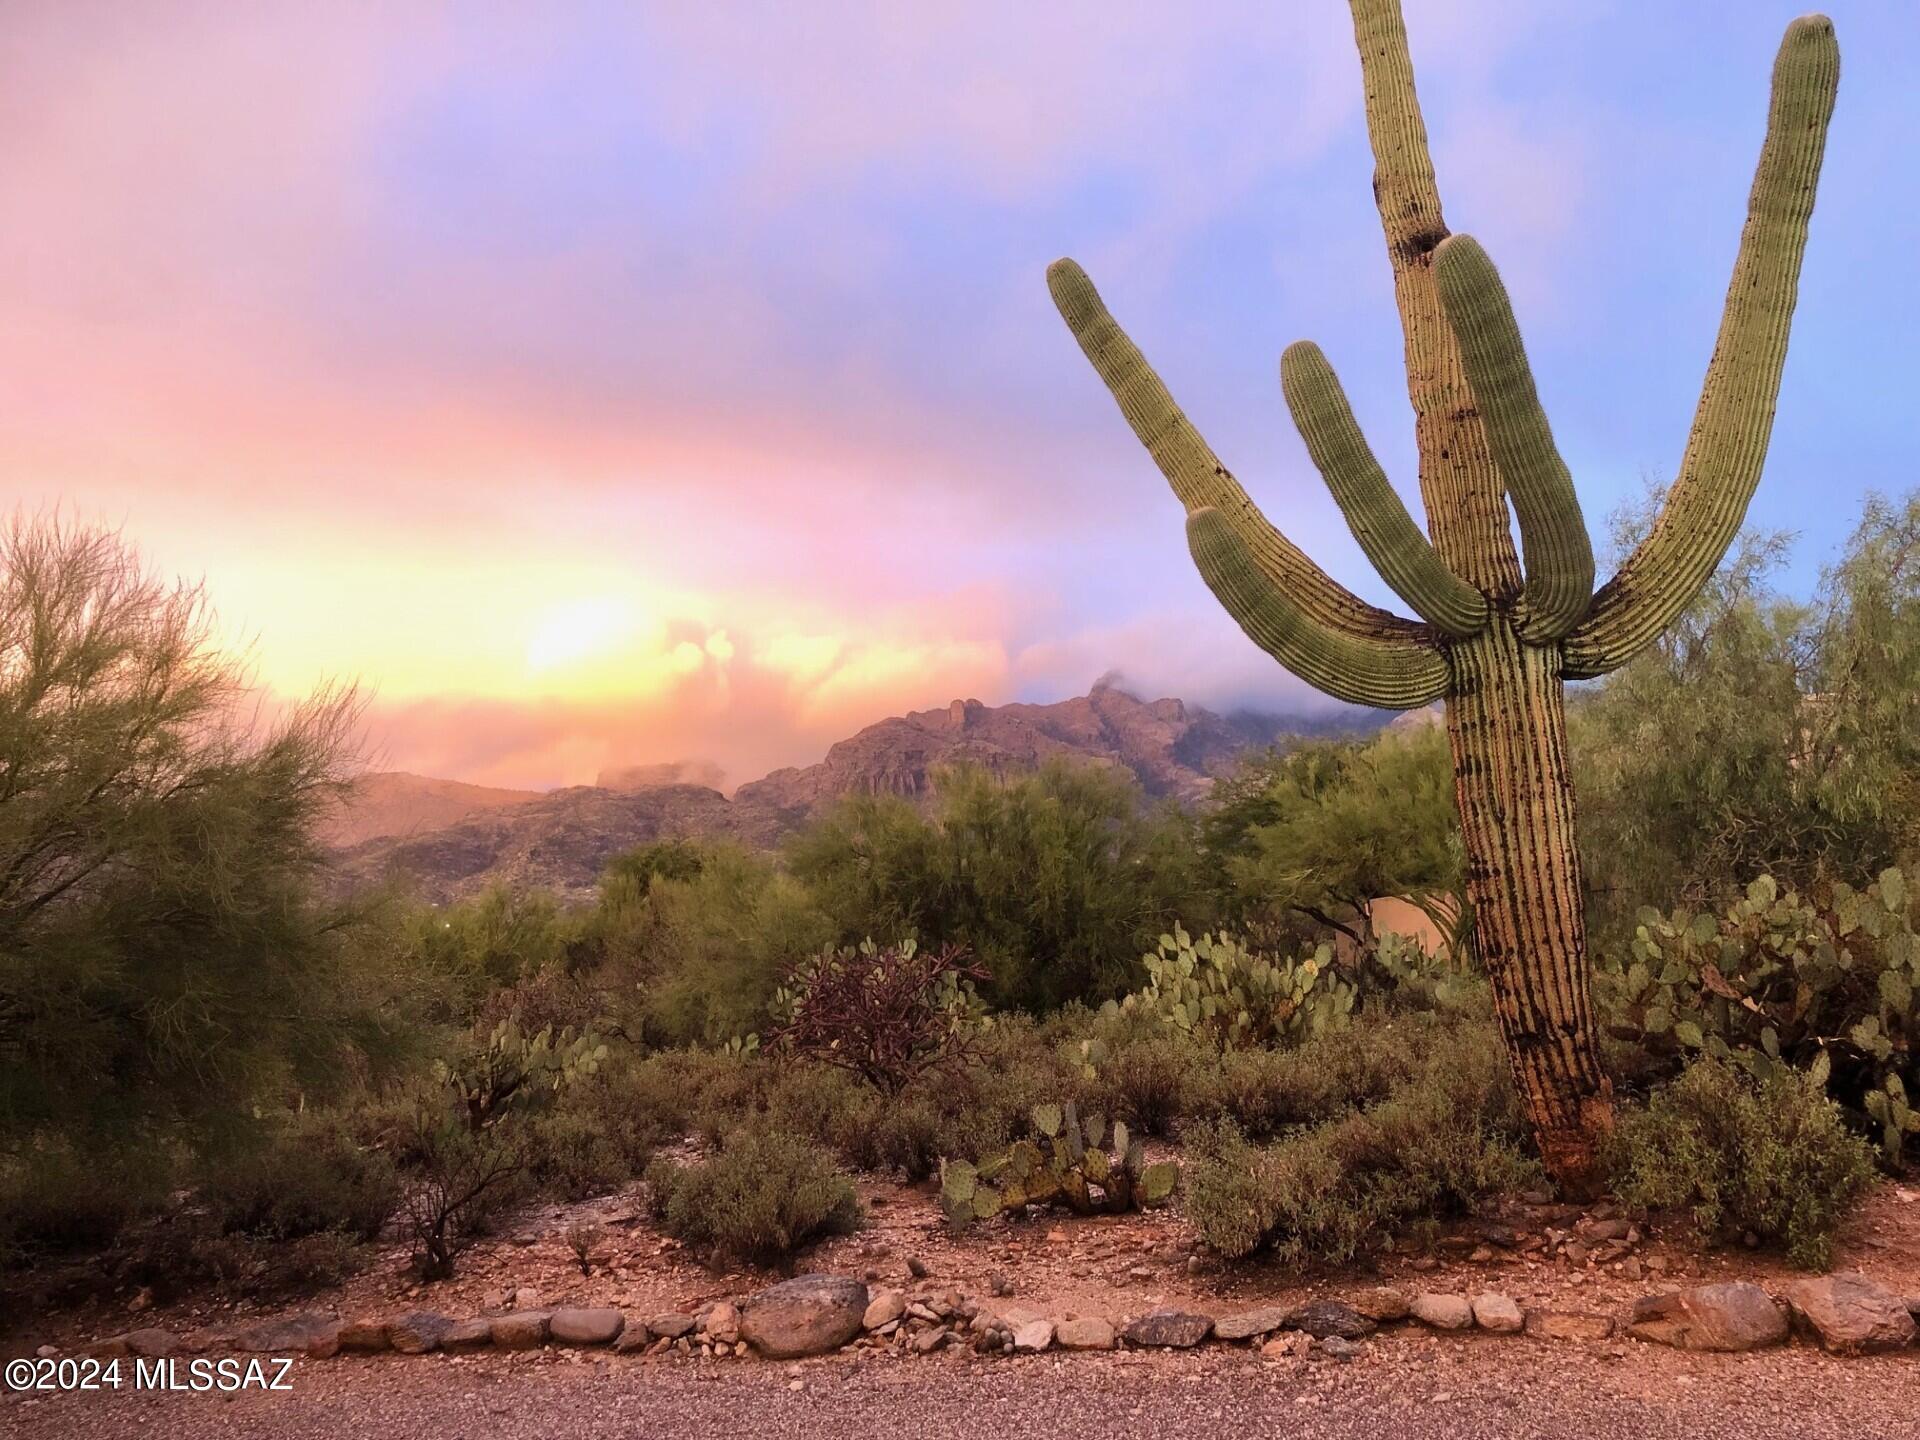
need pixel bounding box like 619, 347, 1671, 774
15, 1181, 1920, 1440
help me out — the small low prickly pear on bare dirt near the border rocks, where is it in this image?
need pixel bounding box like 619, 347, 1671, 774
941, 1100, 1181, 1229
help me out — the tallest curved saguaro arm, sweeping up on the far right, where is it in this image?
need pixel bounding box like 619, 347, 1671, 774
1567, 15, 1839, 680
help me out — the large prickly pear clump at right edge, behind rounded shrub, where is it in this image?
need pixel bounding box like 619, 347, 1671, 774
1599, 870, 1920, 1164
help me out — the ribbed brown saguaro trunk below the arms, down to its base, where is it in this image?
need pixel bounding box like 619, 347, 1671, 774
1446, 618, 1613, 1192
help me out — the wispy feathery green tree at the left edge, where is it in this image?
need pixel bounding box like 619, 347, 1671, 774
0, 518, 408, 1150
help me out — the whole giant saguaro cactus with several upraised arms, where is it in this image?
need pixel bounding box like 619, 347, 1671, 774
1046, 0, 1839, 1190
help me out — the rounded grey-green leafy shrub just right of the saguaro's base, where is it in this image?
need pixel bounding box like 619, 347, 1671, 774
1609, 1058, 1874, 1269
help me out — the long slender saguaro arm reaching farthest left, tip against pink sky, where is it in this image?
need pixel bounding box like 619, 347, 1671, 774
1046, 259, 1427, 643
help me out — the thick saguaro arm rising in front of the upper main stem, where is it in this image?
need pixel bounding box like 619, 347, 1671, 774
1434, 234, 1594, 641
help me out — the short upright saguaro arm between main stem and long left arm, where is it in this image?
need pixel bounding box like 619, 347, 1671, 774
1281, 340, 1486, 636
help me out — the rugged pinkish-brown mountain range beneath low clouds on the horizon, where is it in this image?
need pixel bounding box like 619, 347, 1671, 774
324, 685, 1382, 900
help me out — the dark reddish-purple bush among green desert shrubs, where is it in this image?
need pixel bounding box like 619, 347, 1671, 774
770, 939, 987, 1094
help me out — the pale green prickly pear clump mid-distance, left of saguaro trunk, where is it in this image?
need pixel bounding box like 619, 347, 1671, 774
1119, 925, 1354, 1050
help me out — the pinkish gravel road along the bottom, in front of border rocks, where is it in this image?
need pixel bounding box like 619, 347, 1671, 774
18, 1338, 1920, 1440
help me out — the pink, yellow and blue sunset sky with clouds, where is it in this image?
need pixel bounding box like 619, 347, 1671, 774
0, 0, 1920, 787
